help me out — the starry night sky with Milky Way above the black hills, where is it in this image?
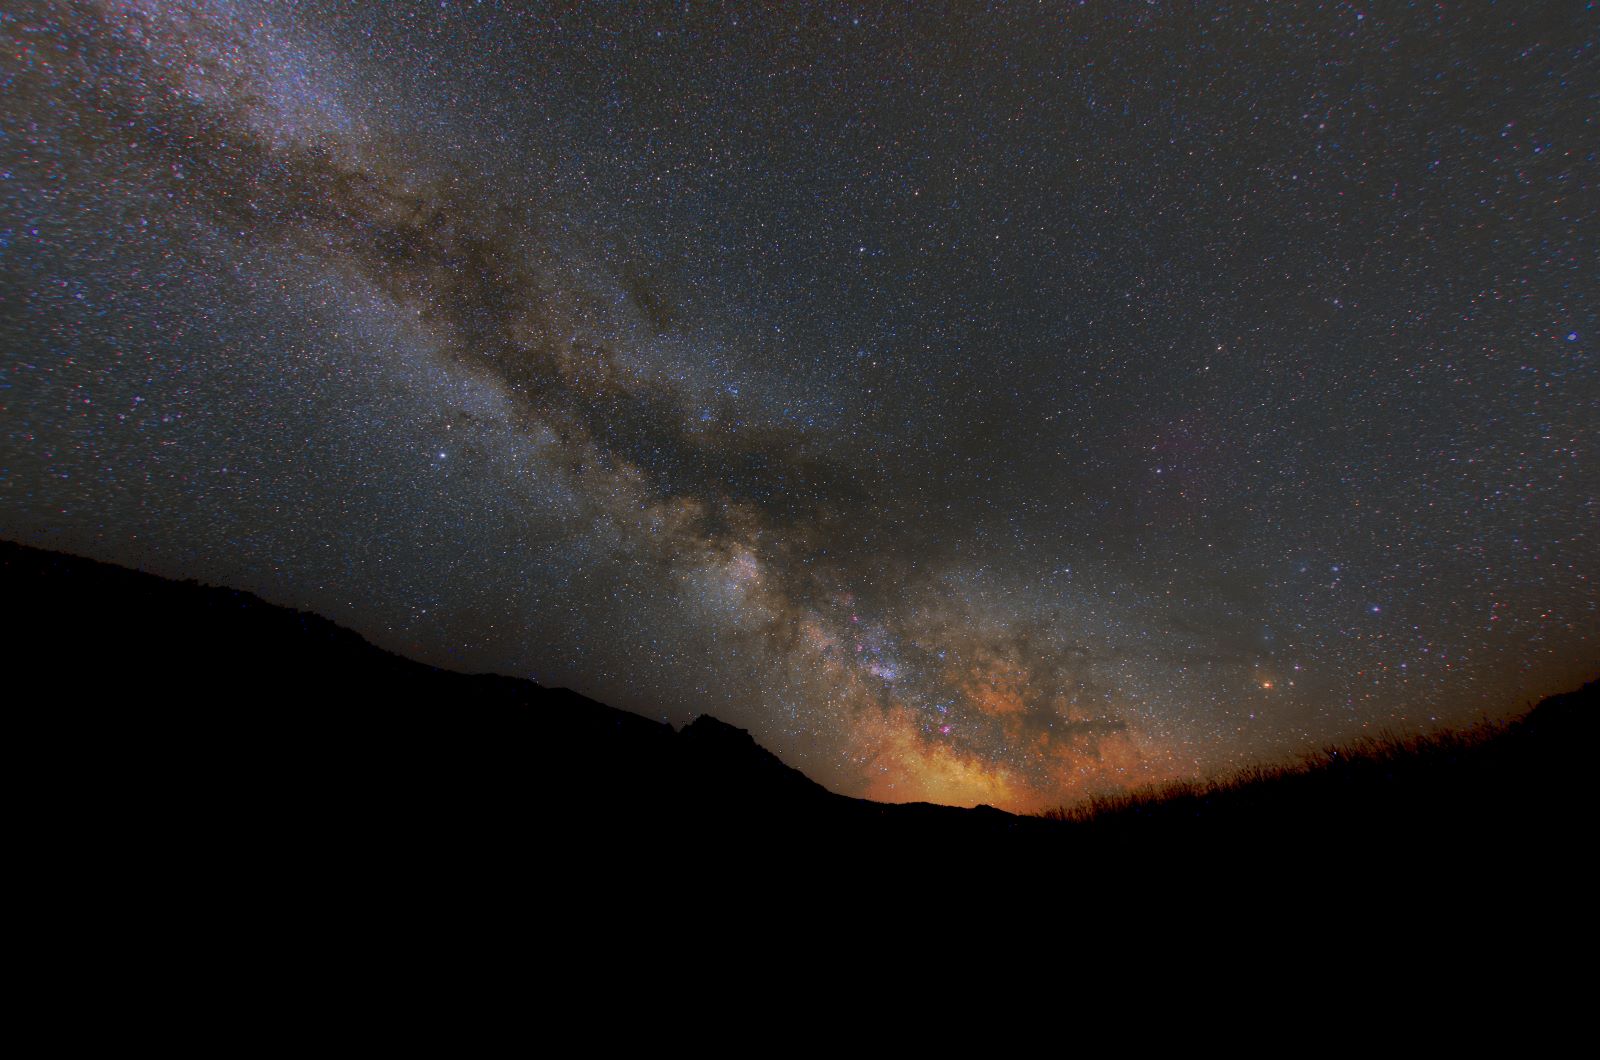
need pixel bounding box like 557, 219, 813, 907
0, 0, 1600, 810
